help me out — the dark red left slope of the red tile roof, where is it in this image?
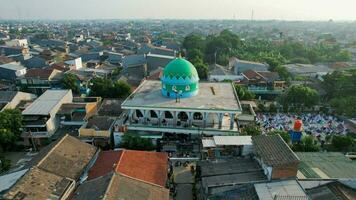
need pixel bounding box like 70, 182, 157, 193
88, 151, 122, 180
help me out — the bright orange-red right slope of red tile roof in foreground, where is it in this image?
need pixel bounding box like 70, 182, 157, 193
116, 150, 168, 187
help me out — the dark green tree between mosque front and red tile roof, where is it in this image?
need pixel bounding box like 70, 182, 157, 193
120, 133, 156, 151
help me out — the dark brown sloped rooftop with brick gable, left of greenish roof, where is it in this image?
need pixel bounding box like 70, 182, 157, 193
252, 135, 299, 167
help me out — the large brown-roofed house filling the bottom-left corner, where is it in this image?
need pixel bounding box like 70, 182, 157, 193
3, 135, 97, 200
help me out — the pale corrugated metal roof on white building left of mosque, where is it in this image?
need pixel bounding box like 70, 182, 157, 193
22, 90, 70, 115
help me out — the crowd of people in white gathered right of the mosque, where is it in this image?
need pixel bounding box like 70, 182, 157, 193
256, 113, 347, 136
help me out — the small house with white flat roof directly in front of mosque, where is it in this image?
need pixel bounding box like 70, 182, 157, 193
202, 136, 252, 159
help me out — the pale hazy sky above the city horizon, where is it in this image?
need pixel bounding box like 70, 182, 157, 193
0, 0, 356, 20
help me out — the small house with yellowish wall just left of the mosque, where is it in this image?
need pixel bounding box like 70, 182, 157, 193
79, 116, 115, 147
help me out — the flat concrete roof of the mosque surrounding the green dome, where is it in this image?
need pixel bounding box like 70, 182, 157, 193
122, 80, 241, 112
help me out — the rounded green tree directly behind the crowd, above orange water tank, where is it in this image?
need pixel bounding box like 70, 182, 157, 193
278, 85, 319, 111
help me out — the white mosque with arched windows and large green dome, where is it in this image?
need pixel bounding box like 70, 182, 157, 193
121, 57, 242, 135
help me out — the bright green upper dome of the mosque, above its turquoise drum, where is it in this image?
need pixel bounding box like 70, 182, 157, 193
163, 58, 199, 79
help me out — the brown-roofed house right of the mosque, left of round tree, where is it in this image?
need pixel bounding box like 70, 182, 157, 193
240, 70, 285, 94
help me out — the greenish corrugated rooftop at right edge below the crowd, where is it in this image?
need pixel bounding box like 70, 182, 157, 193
296, 152, 356, 179
